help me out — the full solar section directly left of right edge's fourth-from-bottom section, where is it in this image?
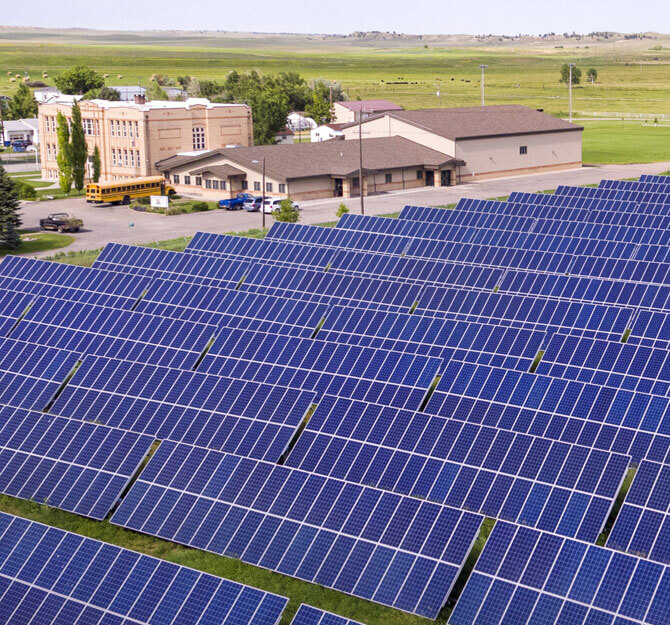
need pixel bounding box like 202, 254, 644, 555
317, 306, 546, 371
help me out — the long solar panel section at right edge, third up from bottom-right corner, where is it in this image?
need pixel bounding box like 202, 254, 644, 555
426, 361, 670, 462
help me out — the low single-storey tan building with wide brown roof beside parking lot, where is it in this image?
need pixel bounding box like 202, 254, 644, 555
156, 136, 463, 200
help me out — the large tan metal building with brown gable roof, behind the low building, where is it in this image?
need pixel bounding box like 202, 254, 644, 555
343, 105, 583, 182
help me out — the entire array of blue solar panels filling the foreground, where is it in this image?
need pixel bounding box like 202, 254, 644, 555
0, 172, 670, 625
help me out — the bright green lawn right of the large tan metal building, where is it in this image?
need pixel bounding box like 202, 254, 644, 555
582, 122, 670, 163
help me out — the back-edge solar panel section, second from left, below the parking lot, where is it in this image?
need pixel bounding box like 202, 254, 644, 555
93, 243, 249, 288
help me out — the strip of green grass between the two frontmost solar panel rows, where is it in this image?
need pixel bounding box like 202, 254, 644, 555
0, 495, 438, 625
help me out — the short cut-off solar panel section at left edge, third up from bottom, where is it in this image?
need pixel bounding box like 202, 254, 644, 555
0, 339, 79, 410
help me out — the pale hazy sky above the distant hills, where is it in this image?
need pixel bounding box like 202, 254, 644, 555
0, 0, 670, 34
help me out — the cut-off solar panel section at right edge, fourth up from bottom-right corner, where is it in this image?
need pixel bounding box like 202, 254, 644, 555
536, 333, 670, 396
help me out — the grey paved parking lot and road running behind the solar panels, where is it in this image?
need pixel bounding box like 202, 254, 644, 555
22, 162, 670, 256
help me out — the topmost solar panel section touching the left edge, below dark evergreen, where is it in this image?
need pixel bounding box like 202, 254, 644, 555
0, 256, 150, 309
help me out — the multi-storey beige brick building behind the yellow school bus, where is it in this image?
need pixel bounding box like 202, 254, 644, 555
39, 96, 253, 182
